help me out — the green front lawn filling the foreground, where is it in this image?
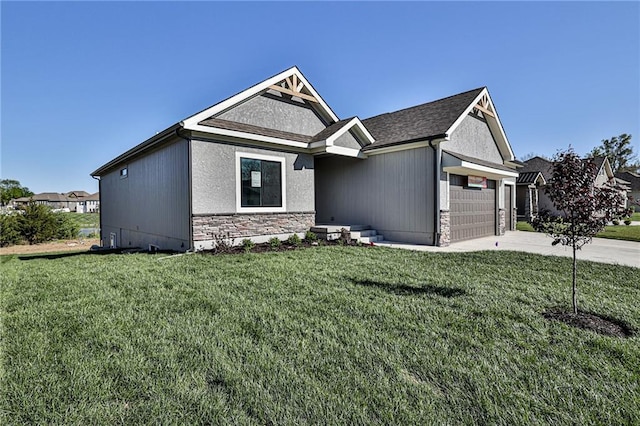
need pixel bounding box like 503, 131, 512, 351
0, 246, 640, 424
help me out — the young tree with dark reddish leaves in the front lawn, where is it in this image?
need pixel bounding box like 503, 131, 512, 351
533, 147, 630, 314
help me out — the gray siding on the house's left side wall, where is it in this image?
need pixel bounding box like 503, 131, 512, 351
100, 140, 190, 250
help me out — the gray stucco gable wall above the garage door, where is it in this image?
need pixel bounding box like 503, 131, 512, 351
442, 115, 503, 164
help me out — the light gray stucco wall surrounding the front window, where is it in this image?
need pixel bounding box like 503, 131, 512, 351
191, 140, 315, 214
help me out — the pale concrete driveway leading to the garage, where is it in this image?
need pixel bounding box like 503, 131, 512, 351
375, 231, 640, 268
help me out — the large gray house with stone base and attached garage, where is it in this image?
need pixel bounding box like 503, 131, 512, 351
91, 67, 518, 251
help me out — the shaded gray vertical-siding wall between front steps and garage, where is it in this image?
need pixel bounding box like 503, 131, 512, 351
316, 148, 435, 244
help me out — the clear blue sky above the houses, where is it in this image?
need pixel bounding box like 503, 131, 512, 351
0, 1, 640, 192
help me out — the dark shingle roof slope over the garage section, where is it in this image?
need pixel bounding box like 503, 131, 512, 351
362, 87, 484, 149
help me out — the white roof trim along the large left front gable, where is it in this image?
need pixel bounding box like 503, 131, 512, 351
183, 66, 339, 127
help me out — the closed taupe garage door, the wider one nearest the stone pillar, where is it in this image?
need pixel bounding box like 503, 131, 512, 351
449, 175, 496, 241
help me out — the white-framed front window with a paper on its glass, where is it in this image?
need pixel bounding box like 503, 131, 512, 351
236, 153, 285, 212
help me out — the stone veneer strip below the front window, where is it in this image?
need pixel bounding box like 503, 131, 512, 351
192, 212, 316, 246
